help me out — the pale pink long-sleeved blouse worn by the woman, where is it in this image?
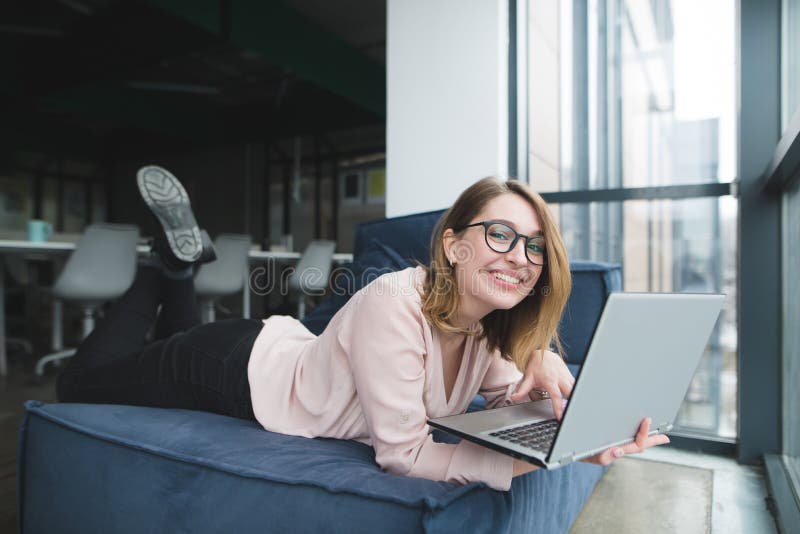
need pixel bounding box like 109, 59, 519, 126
248, 267, 522, 490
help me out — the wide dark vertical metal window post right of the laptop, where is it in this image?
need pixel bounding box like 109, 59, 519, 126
737, 0, 781, 463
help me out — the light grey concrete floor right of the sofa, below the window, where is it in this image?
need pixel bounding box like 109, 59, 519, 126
570, 447, 778, 534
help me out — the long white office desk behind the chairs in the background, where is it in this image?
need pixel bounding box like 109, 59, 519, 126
0, 239, 353, 376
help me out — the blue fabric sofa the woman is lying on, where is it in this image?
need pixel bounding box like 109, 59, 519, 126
18, 212, 620, 534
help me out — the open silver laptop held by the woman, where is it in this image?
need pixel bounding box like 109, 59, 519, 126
428, 293, 725, 469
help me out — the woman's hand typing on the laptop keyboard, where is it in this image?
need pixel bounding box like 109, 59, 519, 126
511, 350, 575, 421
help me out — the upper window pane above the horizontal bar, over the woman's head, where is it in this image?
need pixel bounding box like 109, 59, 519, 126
527, 0, 736, 192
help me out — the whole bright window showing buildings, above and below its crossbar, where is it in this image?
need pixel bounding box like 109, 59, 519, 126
517, 0, 738, 440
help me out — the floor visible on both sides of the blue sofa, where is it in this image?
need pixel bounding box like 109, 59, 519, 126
0, 360, 777, 534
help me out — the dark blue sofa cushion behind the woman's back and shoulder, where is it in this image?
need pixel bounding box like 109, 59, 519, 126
301, 238, 411, 335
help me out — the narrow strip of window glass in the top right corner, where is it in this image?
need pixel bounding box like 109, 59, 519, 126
781, 0, 800, 130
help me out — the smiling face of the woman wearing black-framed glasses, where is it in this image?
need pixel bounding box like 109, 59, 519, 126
443, 193, 542, 325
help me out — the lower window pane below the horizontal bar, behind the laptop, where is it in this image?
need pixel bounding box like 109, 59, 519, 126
554, 197, 738, 437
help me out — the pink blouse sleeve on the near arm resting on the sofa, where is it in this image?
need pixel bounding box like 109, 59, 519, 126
339, 279, 513, 490
